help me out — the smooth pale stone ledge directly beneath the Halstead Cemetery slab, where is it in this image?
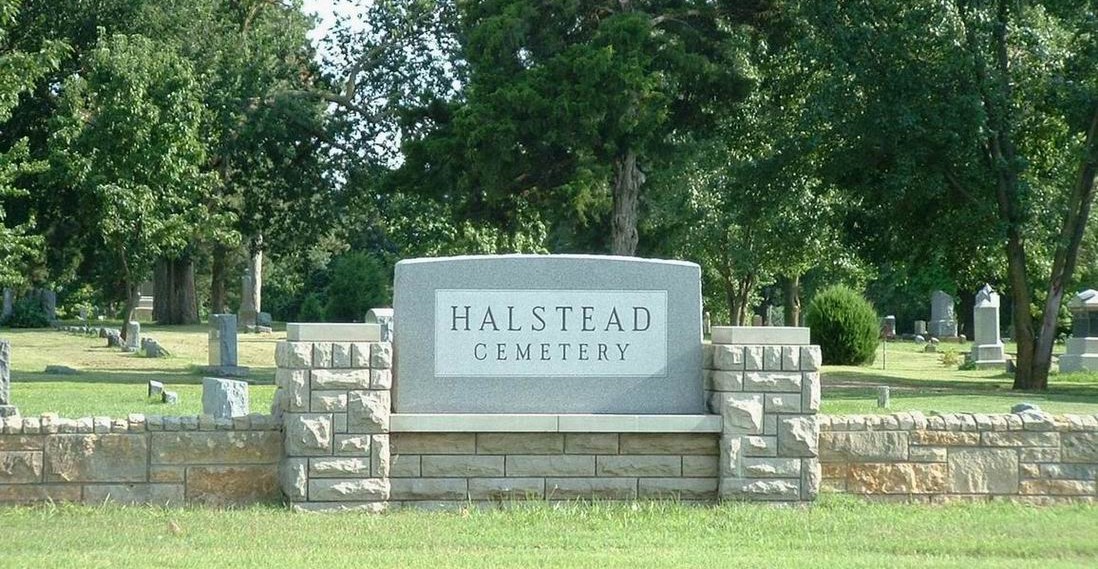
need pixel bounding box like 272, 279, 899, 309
390, 413, 721, 433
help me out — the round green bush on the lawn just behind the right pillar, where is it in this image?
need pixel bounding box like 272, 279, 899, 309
805, 285, 881, 366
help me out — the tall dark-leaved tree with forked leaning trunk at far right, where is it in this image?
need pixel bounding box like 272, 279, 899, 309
804, 0, 1098, 389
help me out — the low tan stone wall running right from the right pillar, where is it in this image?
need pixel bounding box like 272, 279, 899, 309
819, 413, 1098, 503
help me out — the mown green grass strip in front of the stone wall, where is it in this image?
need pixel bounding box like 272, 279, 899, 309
0, 503, 1098, 569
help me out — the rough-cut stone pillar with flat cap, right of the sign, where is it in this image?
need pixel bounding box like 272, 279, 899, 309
704, 326, 820, 502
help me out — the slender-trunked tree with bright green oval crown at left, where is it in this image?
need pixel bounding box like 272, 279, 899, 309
52, 34, 211, 327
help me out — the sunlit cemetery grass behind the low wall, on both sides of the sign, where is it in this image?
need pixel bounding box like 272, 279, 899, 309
3, 323, 1098, 417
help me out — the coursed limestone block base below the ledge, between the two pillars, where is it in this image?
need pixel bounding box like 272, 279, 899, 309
390, 433, 719, 507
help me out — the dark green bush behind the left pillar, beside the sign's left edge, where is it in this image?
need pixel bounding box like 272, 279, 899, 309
324, 252, 393, 322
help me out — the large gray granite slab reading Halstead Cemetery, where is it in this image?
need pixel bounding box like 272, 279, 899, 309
393, 255, 705, 414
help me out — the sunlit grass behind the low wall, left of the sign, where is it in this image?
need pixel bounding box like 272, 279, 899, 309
0, 323, 278, 417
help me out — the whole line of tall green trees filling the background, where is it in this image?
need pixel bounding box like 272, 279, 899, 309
0, 0, 1098, 388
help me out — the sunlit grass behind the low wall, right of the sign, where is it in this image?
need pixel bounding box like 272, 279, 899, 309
820, 342, 1098, 414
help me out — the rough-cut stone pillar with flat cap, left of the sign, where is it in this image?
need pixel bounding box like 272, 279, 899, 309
272, 324, 393, 511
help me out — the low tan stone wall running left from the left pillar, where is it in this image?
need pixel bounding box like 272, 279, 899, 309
0, 414, 281, 505
